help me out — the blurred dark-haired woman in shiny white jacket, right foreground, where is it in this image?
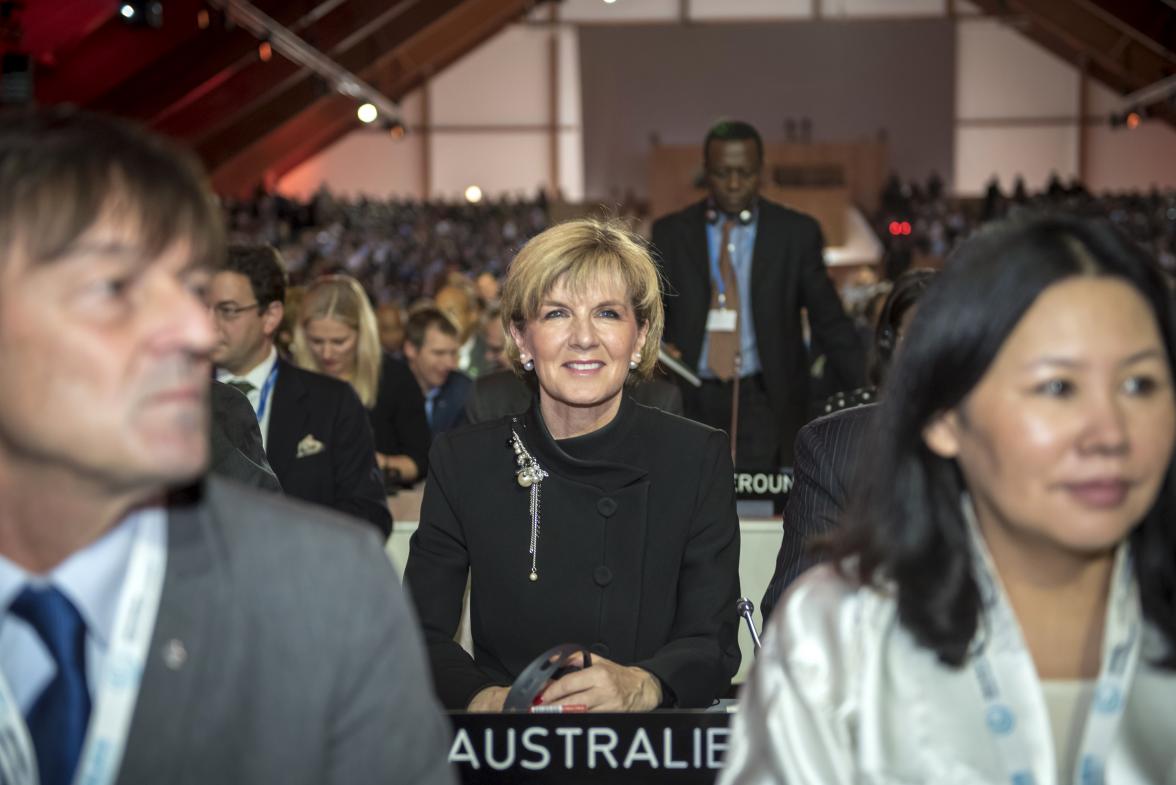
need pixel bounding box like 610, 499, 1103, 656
720, 211, 1176, 785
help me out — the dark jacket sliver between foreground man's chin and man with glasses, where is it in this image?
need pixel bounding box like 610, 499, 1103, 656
208, 381, 282, 494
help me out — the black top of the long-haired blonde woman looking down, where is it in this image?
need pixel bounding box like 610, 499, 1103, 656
368, 353, 433, 477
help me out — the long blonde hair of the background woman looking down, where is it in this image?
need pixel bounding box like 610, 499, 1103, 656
293, 275, 381, 409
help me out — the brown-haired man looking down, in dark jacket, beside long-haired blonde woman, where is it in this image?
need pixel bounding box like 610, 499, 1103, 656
405, 306, 473, 436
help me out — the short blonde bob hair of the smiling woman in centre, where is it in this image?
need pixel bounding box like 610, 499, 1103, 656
501, 219, 666, 380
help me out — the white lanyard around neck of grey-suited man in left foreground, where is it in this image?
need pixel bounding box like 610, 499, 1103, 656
0, 512, 167, 785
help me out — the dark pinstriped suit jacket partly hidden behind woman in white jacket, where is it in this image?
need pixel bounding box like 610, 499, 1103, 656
760, 404, 877, 624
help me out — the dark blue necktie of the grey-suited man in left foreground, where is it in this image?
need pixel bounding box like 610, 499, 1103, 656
12, 586, 89, 785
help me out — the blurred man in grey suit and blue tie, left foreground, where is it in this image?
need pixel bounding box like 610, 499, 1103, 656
0, 108, 456, 785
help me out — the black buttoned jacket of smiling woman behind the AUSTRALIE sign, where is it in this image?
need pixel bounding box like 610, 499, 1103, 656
405, 396, 740, 709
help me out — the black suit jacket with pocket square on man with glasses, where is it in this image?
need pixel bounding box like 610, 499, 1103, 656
266, 357, 392, 537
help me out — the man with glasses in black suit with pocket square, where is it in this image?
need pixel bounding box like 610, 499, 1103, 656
207, 246, 392, 536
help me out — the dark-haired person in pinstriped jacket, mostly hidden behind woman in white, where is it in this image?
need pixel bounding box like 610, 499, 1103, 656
760, 269, 935, 624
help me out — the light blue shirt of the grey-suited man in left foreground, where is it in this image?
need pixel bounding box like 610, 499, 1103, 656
0, 506, 167, 717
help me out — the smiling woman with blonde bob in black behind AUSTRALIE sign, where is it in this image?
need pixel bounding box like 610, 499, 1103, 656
405, 220, 739, 711
